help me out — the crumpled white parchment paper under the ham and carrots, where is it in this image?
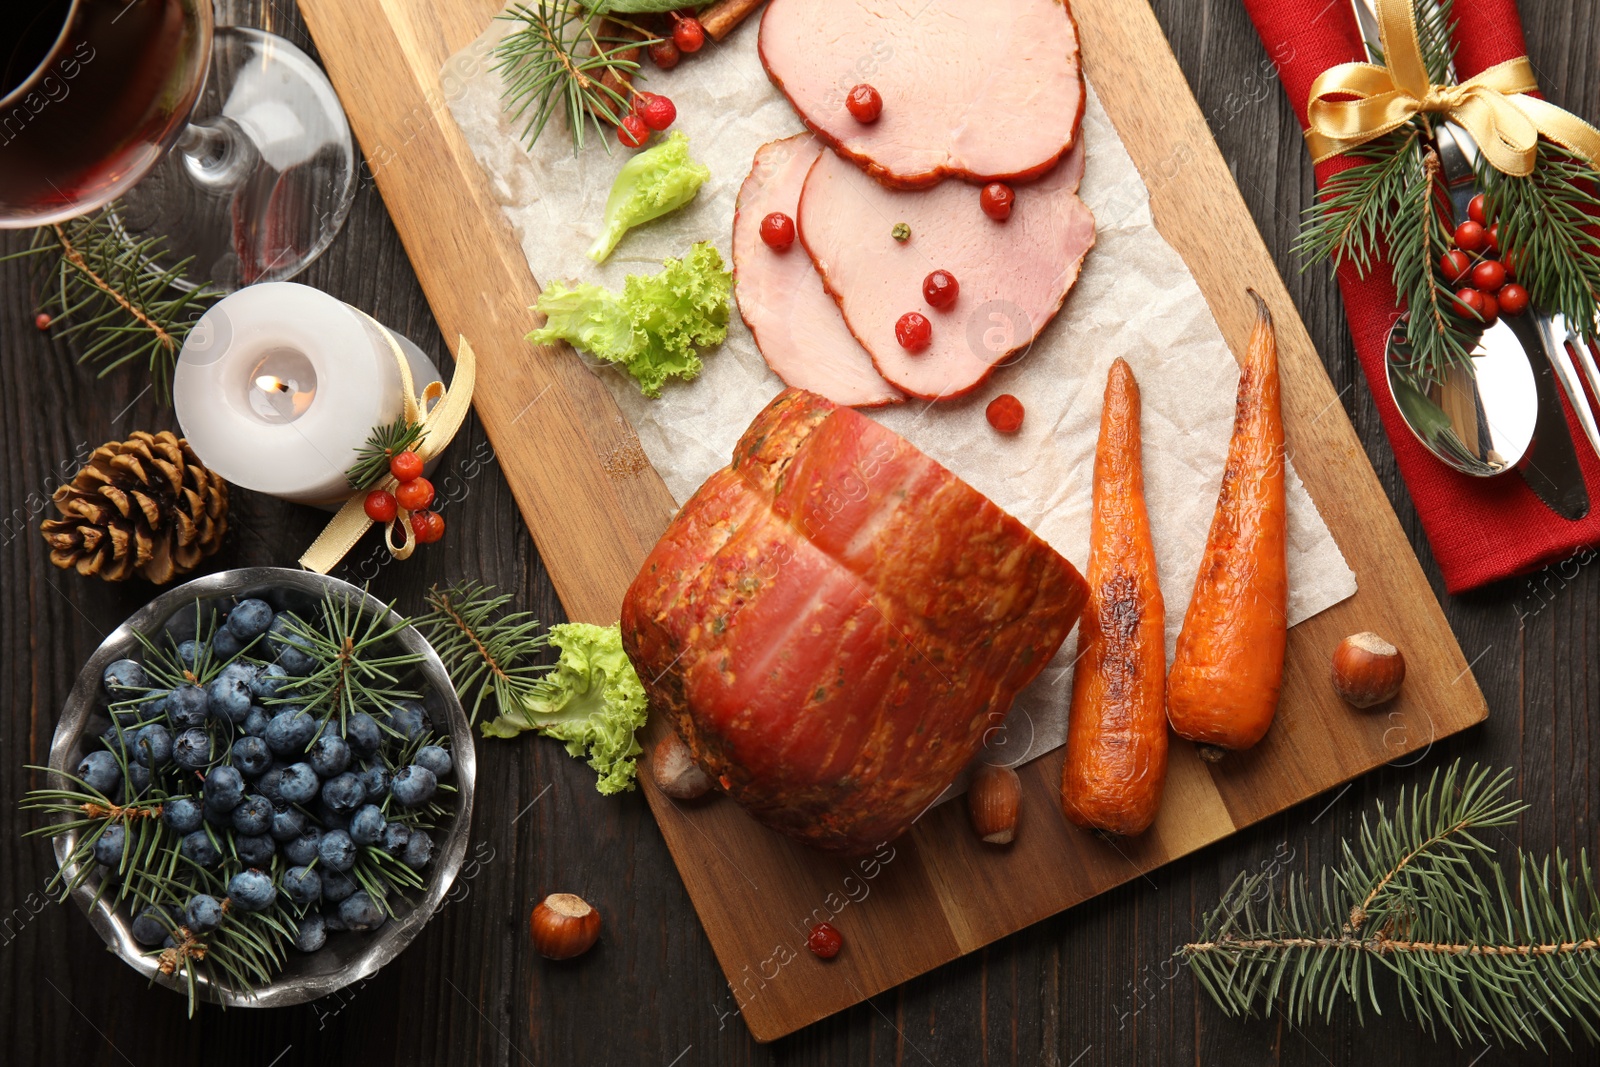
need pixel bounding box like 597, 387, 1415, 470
442, 18, 1355, 761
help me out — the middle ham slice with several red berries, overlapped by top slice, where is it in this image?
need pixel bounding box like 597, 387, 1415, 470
798, 137, 1094, 400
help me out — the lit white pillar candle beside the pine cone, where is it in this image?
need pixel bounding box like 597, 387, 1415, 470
173, 282, 438, 506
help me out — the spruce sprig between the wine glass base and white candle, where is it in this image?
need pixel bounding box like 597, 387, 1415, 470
0, 203, 222, 405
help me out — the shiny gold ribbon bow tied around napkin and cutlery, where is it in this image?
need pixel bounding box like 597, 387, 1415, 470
1306, 0, 1600, 178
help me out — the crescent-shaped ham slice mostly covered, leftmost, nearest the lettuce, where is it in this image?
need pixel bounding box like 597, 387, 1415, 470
733, 133, 906, 408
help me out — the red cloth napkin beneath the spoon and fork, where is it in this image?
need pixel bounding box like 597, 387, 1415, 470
1245, 0, 1600, 593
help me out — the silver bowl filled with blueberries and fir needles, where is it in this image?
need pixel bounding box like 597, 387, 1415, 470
45, 568, 475, 1009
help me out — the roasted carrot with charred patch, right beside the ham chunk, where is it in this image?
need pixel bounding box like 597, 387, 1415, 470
1061, 360, 1166, 833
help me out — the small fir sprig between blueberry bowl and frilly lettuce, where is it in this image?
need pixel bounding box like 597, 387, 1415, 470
416, 582, 549, 723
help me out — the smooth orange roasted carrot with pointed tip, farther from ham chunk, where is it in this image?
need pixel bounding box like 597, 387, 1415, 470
1166, 293, 1288, 760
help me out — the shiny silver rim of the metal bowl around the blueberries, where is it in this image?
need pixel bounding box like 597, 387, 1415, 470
50, 566, 477, 1008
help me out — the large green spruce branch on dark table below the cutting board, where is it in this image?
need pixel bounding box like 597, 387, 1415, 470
1181, 761, 1600, 1048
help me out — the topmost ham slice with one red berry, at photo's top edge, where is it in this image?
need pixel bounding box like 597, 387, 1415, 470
760, 0, 1083, 189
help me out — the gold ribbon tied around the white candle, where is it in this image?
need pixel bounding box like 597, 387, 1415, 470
301, 319, 477, 574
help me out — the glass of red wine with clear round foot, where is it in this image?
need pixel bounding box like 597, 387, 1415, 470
0, 0, 355, 291
